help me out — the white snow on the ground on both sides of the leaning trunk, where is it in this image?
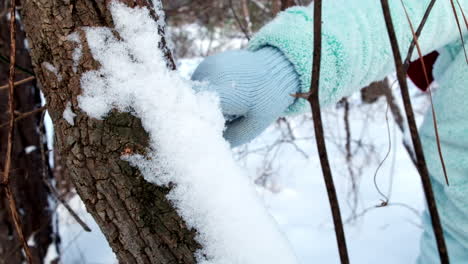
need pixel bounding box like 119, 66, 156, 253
52, 52, 432, 264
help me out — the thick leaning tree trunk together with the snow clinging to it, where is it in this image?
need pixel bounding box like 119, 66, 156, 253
23, 0, 296, 264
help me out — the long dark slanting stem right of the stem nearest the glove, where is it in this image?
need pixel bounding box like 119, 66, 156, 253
380, 0, 449, 264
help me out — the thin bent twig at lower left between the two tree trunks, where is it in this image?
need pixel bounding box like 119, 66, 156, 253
39, 112, 91, 232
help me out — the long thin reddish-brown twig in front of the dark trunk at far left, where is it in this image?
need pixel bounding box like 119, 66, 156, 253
2, 0, 33, 264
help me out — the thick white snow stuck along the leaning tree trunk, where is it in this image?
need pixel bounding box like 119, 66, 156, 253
78, 3, 296, 264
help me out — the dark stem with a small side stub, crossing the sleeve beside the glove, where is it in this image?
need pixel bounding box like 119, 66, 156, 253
296, 0, 349, 264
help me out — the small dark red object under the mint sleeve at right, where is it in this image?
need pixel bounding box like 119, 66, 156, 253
407, 51, 439, 91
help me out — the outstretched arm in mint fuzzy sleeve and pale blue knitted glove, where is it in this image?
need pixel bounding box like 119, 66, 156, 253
192, 0, 468, 146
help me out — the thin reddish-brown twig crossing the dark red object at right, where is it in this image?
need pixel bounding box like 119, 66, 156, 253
400, 0, 449, 186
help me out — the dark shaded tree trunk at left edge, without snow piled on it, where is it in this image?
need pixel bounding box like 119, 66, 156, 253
0, 0, 53, 264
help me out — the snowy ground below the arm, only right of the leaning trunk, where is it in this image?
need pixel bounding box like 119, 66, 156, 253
247, 94, 430, 264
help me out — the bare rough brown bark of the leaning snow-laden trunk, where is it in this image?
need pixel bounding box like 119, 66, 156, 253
21, 0, 200, 264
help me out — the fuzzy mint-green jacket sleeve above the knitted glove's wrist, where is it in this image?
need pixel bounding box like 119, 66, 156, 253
249, 0, 468, 113
